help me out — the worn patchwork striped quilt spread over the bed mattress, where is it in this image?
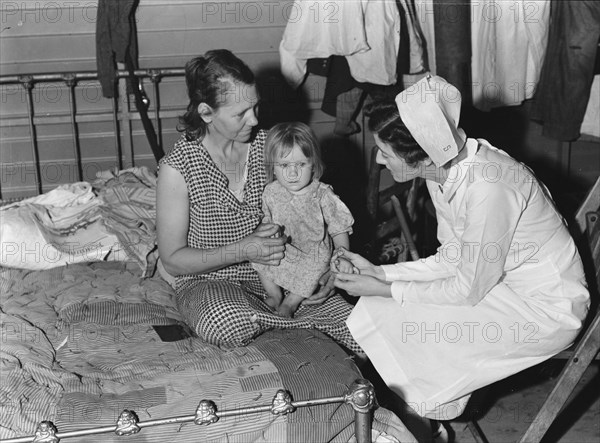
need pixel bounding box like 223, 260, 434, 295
0, 262, 414, 443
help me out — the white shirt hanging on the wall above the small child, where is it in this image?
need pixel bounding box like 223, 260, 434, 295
279, 0, 400, 88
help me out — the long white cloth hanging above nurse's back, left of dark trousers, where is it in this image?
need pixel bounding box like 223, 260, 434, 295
471, 0, 552, 111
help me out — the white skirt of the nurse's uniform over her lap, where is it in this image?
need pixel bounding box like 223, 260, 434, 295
347, 246, 589, 420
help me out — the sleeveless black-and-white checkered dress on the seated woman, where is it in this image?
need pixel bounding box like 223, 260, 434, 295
161, 130, 362, 352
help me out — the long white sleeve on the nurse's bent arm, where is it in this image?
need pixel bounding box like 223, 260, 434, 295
391, 181, 526, 305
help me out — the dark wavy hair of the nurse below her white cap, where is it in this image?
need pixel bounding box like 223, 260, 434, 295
364, 95, 427, 166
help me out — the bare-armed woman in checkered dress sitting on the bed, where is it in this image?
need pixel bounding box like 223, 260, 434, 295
157, 50, 361, 352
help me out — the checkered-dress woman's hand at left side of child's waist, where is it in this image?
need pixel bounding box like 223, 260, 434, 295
240, 223, 287, 266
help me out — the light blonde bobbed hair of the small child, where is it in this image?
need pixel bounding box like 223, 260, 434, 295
265, 122, 325, 183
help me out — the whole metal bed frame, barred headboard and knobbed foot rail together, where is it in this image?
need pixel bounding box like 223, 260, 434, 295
0, 69, 377, 443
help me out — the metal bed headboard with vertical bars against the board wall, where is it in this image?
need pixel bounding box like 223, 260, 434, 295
0, 68, 187, 203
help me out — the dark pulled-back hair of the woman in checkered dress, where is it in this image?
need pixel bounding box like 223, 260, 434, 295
177, 49, 256, 140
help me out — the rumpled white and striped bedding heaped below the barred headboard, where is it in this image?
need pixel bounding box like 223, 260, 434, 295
0, 167, 157, 277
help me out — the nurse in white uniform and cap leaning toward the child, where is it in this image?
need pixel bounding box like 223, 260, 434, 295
335, 76, 589, 430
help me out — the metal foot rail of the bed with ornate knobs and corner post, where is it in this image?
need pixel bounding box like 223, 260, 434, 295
0, 378, 377, 443
